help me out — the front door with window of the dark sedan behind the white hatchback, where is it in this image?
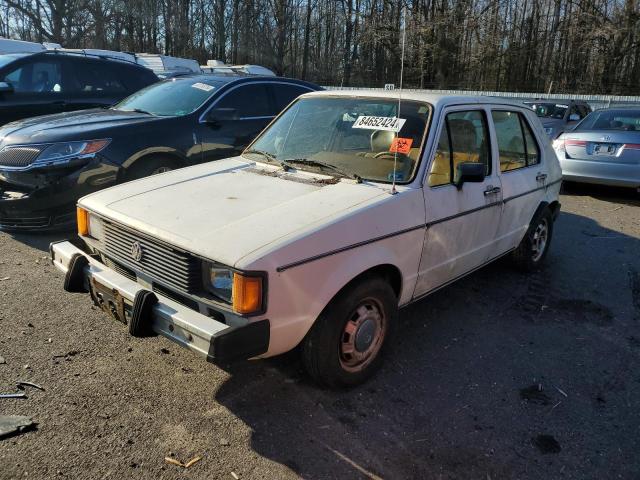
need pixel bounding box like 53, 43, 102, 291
198, 82, 275, 162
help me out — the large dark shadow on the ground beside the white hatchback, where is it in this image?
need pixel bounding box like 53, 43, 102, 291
214, 209, 640, 479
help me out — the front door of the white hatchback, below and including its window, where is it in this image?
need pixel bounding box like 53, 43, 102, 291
414, 106, 502, 296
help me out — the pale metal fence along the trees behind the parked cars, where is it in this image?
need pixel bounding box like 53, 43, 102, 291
324, 87, 640, 109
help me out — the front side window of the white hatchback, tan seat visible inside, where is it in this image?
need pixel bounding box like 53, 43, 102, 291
427, 110, 491, 187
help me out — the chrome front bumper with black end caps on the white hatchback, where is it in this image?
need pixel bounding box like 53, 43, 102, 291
50, 241, 270, 362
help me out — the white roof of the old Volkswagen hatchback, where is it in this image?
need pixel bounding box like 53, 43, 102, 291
304, 89, 525, 108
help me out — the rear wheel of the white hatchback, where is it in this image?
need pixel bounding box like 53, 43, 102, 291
512, 207, 553, 272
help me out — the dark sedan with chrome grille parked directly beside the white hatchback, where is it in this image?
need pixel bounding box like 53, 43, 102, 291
0, 75, 320, 230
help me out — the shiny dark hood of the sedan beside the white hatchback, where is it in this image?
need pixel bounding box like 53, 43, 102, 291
0, 109, 162, 147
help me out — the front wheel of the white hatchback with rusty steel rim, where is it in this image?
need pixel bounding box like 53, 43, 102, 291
301, 277, 398, 388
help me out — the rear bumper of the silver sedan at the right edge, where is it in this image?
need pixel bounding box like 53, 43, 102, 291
560, 158, 640, 188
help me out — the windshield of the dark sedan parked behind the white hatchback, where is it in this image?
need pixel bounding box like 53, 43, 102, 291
113, 78, 219, 117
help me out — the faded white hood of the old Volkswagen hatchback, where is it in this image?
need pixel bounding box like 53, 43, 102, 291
80, 157, 390, 268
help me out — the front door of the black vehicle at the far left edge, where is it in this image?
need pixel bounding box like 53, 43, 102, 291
0, 55, 66, 124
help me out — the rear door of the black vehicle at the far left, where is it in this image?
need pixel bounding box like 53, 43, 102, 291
64, 57, 127, 111
